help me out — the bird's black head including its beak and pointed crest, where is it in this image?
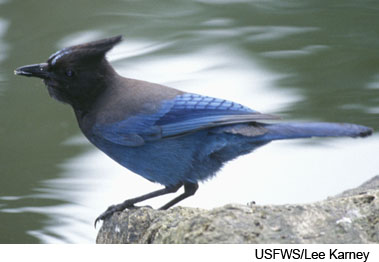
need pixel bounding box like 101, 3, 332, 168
15, 36, 122, 109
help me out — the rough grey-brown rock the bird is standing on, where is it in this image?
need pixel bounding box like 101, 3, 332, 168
96, 176, 379, 244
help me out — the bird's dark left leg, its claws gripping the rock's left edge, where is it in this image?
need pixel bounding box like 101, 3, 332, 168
95, 183, 183, 227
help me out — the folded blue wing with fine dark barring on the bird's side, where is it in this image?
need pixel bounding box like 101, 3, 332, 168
93, 93, 276, 146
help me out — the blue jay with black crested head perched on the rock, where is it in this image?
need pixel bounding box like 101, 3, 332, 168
14, 35, 373, 227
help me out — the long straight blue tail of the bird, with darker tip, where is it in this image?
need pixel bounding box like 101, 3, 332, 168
264, 122, 373, 140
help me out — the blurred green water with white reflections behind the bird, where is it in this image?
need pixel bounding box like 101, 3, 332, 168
0, 0, 379, 243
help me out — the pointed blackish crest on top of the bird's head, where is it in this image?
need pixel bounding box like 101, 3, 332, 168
48, 35, 123, 65
